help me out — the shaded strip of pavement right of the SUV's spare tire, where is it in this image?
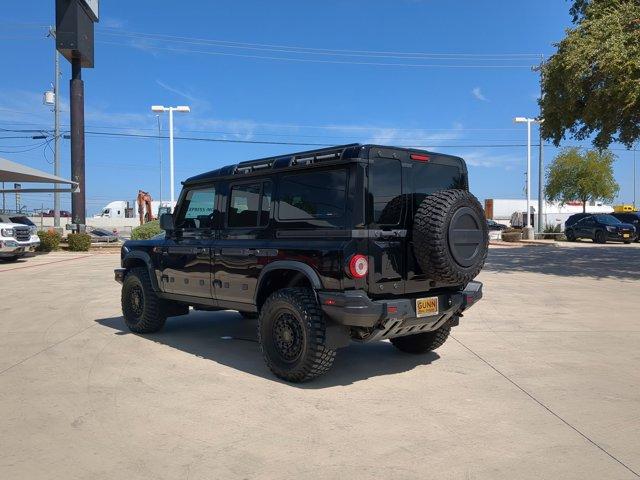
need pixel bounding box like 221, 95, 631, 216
484, 245, 640, 280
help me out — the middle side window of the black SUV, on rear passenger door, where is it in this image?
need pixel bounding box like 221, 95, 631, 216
227, 182, 271, 228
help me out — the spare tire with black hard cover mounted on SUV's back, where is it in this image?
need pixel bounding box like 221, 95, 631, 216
413, 190, 489, 285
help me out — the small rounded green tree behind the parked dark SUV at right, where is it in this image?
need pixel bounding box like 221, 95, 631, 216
545, 148, 620, 212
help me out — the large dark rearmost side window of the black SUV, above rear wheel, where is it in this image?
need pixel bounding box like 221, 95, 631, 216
278, 168, 347, 224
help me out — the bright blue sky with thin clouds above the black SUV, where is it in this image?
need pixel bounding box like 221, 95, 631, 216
0, 0, 633, 213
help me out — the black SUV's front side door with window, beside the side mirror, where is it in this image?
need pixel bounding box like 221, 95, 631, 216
161, 185, 218, 298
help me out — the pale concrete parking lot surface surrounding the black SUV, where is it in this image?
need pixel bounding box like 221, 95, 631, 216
0, 243, 640, 480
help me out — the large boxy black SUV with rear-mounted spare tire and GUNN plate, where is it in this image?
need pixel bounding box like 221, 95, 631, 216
115, 144, 488, 382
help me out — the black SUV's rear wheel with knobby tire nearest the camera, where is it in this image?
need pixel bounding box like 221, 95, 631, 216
258, 288, 336, 383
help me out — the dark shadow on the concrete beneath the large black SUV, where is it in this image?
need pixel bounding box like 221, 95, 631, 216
96, 311, 440, 389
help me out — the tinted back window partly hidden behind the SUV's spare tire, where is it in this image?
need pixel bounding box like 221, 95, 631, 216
411, 162, 467, 209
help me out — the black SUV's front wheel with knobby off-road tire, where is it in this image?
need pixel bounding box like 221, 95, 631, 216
121, 267, 167, 333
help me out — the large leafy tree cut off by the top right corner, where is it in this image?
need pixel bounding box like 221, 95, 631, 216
540, 0, 640, 149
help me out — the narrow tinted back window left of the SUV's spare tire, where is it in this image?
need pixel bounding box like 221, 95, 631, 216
369, 158, 402, 225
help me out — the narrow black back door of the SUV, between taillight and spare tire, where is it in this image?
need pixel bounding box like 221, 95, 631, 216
367, 158, 407, 296
